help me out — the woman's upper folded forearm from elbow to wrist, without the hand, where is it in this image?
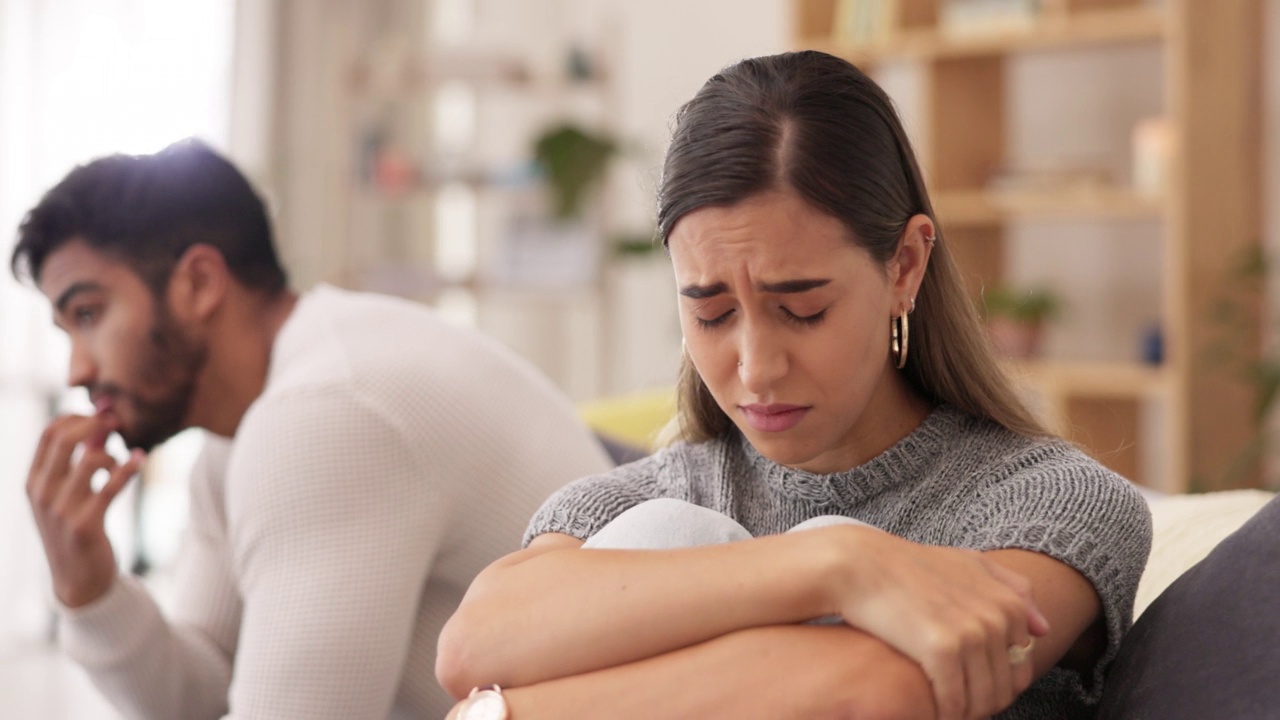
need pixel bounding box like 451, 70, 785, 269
436, 528, 849, 696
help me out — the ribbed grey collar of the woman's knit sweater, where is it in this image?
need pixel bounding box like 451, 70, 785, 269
737, 405, 966, 507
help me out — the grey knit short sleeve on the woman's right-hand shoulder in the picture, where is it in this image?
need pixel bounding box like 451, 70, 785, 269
964, 442, 1152, 705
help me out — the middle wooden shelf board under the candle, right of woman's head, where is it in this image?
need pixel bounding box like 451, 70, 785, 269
933, 186, 1165, 227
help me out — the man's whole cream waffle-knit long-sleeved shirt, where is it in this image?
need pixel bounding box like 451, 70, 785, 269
63, 287, 609, 720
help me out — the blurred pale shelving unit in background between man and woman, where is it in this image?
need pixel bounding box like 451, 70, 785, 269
330, 0, 627, 400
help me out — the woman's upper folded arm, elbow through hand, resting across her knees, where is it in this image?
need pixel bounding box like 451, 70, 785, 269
436, 525, 1047, 717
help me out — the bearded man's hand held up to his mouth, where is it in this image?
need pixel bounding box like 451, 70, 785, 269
27, 415, 143, 607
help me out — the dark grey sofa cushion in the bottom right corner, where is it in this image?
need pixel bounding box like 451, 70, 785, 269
1098, 489, 1280, 720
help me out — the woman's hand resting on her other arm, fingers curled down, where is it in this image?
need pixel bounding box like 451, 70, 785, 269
833, 529, 1048, 720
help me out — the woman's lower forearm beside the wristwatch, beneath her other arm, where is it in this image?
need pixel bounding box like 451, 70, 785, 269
449, 625, 934, 720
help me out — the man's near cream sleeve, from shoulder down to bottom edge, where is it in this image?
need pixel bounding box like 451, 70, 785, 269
227, 388, 448, 720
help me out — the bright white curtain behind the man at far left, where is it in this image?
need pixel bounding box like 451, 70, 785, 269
0, 0, 238, 650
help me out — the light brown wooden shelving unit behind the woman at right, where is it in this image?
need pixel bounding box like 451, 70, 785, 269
792, 0, 1262, 492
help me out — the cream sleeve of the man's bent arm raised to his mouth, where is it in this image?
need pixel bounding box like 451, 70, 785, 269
61, 438, 239, 720
